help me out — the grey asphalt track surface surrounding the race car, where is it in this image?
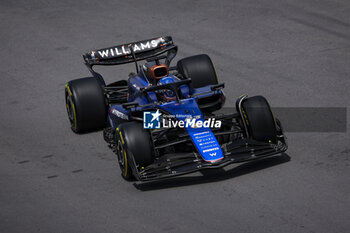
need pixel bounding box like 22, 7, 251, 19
0, 0, 350, 233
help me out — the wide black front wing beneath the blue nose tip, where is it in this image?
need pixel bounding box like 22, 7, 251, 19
129, 136, 288, 181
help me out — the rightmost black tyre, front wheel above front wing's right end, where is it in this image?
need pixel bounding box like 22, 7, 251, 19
242, 96, 277, 143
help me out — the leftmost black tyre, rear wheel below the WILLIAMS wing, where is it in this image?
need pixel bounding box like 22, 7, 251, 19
65, 78, 107, 133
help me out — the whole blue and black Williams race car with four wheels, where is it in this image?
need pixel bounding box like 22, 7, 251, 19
65, 36, 287, 181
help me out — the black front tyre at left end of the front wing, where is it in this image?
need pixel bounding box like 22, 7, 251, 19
115, 122, 154, 180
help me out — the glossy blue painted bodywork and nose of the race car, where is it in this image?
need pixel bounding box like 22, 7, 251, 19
108, 71, 224, 162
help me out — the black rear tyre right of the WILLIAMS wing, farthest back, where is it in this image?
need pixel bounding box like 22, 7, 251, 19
177, 54, 218, 88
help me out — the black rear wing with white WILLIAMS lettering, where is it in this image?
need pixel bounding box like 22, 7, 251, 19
83, 36, 177, 68
